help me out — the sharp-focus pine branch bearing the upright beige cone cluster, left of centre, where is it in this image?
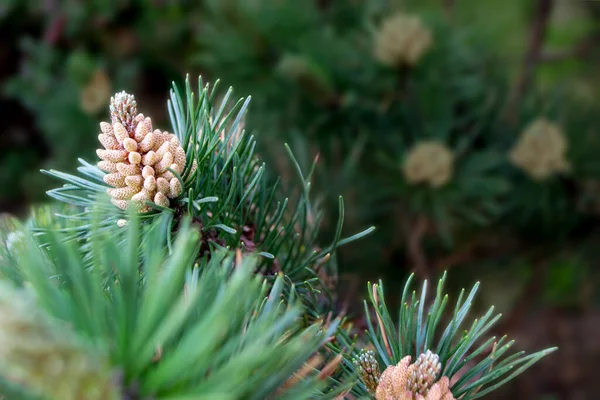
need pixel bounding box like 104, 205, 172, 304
39, 75, 373, 312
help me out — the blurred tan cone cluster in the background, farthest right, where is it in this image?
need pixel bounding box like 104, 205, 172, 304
509, 118, 569, 181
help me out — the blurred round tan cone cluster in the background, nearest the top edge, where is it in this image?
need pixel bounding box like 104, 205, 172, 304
374, 13, 433, 67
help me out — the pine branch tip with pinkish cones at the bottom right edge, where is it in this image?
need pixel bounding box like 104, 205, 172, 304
331, 274, 556, 400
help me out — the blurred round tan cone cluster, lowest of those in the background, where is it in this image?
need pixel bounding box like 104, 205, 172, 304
402, 141, 454, 188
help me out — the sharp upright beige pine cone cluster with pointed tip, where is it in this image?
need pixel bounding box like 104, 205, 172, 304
96, 92, 185, 212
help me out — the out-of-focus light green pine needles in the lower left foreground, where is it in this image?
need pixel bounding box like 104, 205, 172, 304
0, 214, 350, 400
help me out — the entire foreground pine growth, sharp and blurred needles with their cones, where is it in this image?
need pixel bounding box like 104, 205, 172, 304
0, 74, 553, 400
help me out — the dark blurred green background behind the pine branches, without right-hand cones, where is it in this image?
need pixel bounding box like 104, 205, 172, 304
0, 0, 600, 399
